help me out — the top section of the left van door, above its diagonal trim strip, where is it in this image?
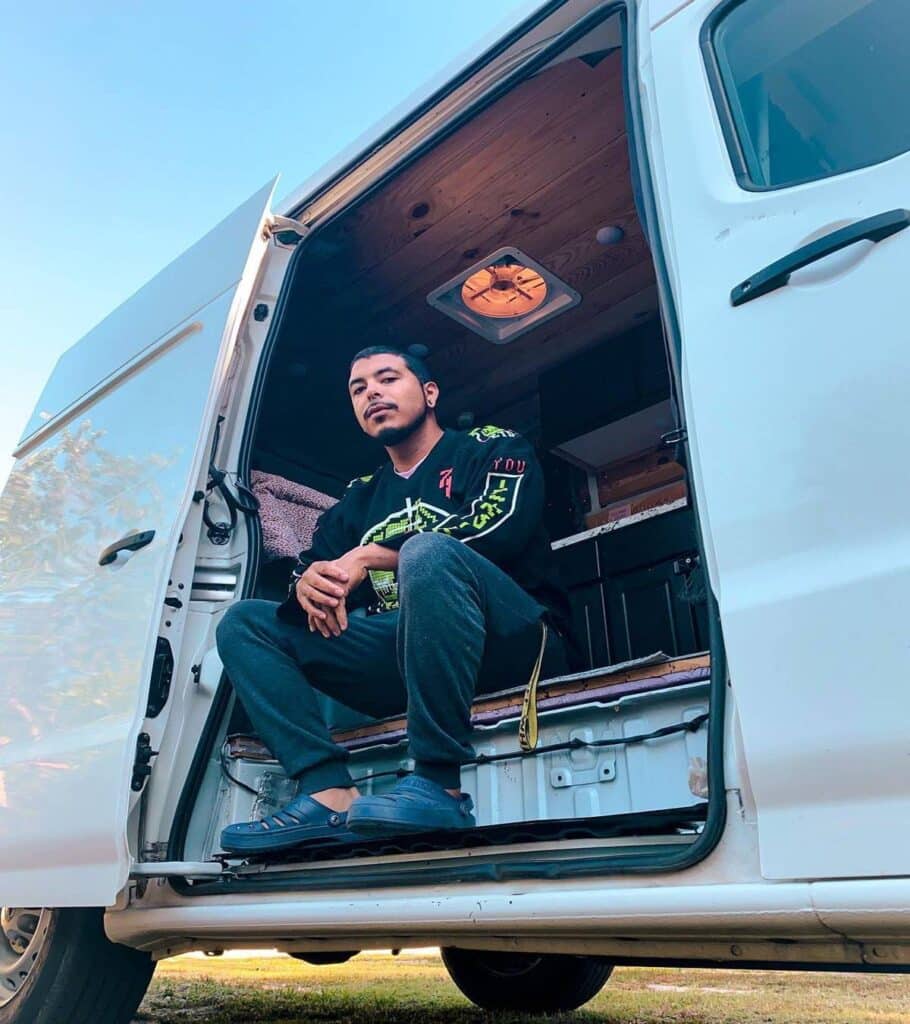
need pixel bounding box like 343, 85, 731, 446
19, 178, 277, 446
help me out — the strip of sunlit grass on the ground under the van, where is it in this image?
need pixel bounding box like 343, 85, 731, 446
135, 953, 910, 1024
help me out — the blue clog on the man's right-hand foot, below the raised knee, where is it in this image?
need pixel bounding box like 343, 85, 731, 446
348, 775, 477, 836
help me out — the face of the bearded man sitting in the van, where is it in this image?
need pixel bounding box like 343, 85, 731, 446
348, 353, 437, 445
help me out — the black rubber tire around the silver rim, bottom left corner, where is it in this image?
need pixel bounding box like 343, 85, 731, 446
0, 908, 155, 1024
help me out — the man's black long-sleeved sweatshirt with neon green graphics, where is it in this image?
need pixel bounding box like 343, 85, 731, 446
278, 427, 568, 633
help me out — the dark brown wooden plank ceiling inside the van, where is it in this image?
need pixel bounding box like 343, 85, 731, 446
258, 50, 657, 479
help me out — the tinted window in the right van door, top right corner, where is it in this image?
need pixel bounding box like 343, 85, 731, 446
705, 0, 910, 189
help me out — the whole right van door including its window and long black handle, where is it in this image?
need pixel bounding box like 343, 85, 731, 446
640, 0, 910, 879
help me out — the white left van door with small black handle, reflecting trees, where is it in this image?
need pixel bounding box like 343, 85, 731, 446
0, 181, 274, 907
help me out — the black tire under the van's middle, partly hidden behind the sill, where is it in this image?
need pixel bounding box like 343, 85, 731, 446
441, 946, 613, 1014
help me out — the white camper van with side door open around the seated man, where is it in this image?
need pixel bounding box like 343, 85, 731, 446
0, 0, 910, 1024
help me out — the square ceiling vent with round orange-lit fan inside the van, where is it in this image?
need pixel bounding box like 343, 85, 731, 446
427, 246, 581, 345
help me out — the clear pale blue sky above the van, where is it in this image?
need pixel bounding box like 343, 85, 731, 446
0, 0, 530, 484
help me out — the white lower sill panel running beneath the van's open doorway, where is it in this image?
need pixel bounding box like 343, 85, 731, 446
105, 876, 908, 963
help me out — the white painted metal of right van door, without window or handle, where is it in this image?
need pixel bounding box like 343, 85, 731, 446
646, 0, 910, 880
